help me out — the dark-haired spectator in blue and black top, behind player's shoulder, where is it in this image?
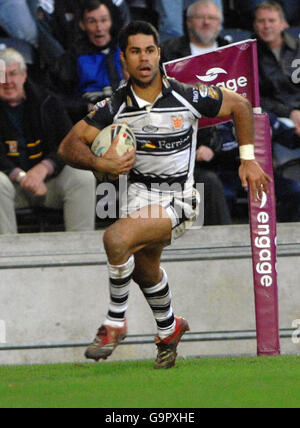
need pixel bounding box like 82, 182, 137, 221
49, 0, 123, 122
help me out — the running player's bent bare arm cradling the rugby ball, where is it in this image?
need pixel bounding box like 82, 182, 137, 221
58, 120, 135, 175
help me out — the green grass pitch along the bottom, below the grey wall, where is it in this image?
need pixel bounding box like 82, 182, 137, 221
0, 356, 300, 409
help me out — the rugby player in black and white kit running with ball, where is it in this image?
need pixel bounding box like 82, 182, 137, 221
59, 21, 271, 369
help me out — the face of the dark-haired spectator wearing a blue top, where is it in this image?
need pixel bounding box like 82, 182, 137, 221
80, 4, 112, 48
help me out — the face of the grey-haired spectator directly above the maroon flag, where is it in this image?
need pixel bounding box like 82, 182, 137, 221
187, 4, 221, 45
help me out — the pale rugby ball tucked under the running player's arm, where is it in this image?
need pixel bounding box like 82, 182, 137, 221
91, 123, 136, 181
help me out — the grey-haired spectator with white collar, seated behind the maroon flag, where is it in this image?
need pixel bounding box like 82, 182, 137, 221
162, 0, 231, 225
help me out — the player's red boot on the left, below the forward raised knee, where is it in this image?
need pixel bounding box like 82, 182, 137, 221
85, 321, 127, 361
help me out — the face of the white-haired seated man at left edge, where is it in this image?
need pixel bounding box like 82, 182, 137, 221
0, 63, 27, 105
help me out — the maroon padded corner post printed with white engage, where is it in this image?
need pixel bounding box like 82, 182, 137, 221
249, 114, 280, 356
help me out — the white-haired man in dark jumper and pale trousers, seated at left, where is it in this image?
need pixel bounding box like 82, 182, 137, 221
0, 49, 96, 234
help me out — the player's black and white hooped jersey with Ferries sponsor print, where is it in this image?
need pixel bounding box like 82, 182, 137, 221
85, 77, 223, 189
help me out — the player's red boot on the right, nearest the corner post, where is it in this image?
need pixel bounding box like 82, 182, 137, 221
154, 317, 190, 369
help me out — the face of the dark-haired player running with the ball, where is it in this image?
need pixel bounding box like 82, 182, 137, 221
122, 34, 160, 87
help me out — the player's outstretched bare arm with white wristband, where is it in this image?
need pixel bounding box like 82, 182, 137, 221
218, 88, 272, 201
